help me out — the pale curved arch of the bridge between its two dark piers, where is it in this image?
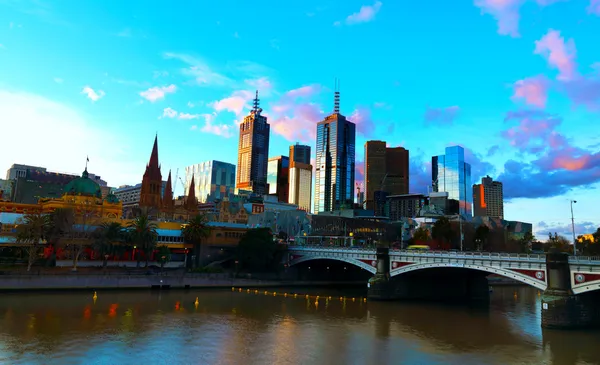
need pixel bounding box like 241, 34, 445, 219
390, 263, 548, 290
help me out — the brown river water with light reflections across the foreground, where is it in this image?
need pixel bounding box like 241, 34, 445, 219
0, 287, 600, 365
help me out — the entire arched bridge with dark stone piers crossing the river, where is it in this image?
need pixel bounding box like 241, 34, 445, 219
287, 246, 600, 328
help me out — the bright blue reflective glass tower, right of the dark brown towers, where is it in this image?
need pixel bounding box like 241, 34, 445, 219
431, 146, 473, 217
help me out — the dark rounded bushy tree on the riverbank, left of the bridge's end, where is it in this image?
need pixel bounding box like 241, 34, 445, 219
236, 228, 277, 272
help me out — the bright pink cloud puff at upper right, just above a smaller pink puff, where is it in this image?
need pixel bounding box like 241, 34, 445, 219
534, 29, 577, 80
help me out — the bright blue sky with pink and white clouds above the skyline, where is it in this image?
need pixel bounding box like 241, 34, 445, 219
0, 0, 600, 239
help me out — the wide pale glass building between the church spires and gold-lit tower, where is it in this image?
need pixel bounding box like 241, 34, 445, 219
185, 160, 235, 203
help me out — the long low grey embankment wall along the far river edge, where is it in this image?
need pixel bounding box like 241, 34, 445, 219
0, 273, 364, 292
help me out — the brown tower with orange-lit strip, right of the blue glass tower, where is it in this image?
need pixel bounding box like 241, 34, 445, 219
473, 176, 504, 219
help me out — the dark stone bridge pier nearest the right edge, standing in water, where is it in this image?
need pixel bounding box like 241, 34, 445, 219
541, 252, 600, 329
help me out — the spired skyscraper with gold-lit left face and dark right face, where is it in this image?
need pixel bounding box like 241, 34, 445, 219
235, 90, 270, 195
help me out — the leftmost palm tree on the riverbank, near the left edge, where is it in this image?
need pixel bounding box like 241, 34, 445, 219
17, 214, 50, 271
